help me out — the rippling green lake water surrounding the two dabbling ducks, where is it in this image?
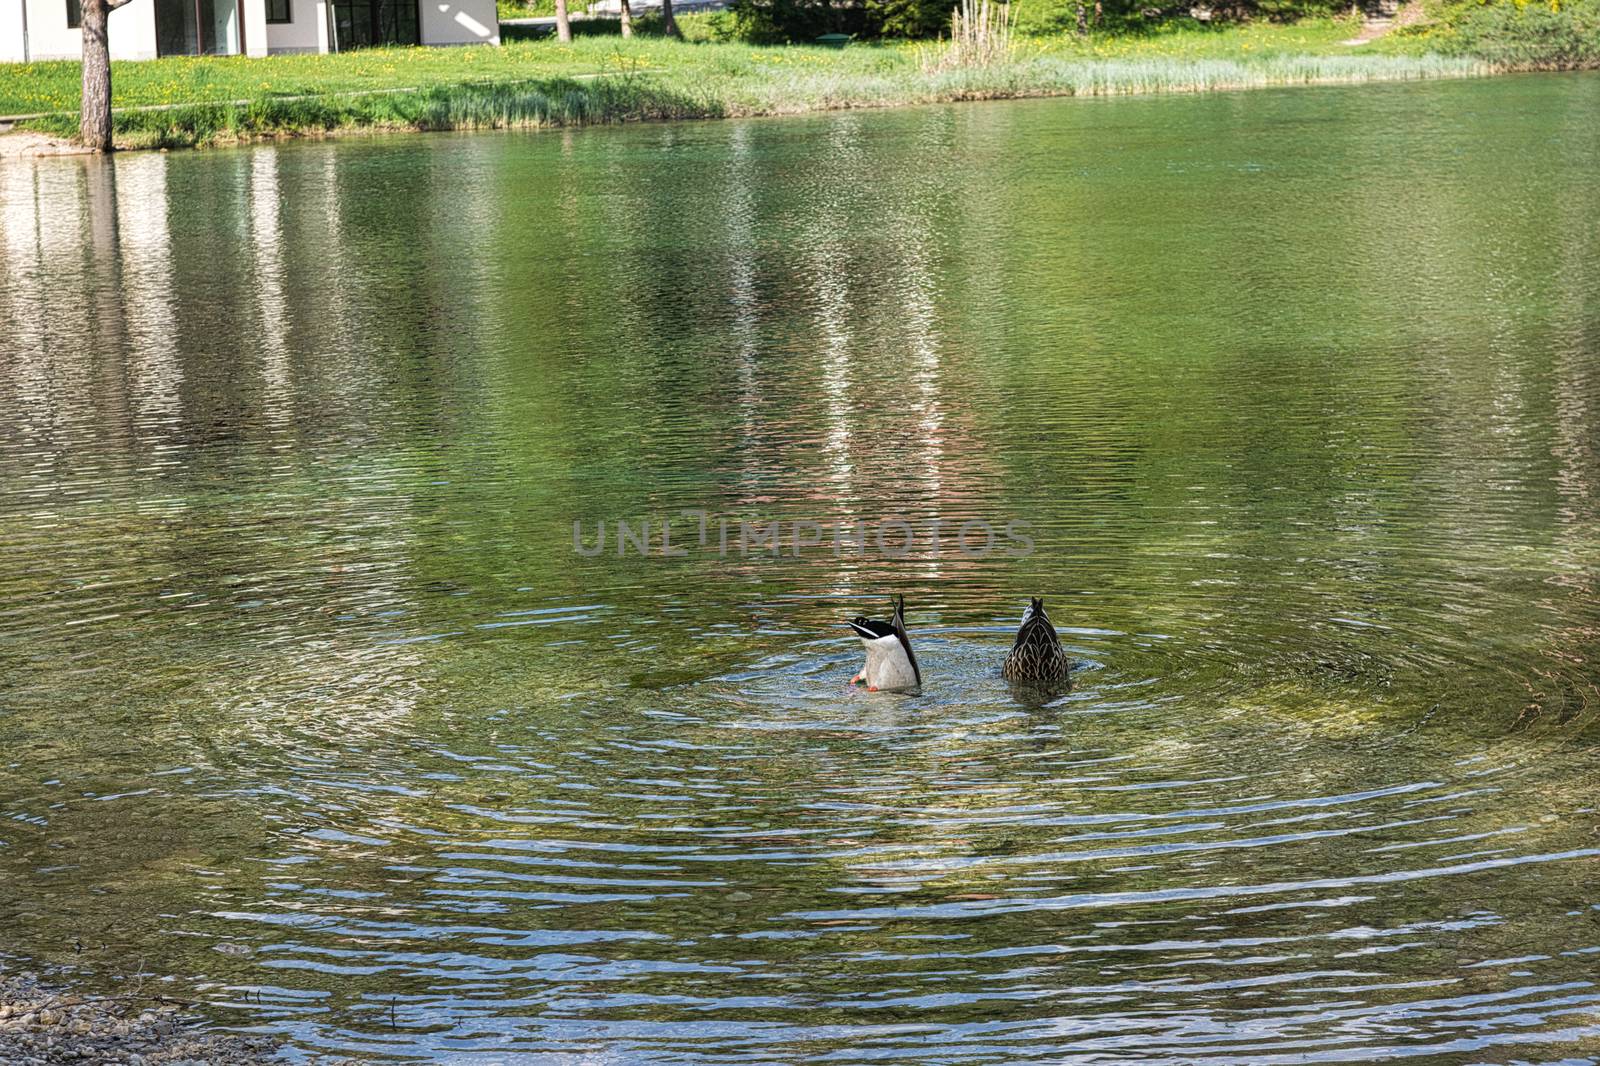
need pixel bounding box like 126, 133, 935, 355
0, 75, 1600, 1066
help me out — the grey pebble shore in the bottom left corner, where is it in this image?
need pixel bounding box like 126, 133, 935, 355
0, 973, 283, 1066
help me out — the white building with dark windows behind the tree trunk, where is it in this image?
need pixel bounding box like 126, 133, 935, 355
0, 0, 499, 62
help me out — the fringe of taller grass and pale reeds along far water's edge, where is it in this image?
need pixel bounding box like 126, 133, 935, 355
0, 53, 1510, 160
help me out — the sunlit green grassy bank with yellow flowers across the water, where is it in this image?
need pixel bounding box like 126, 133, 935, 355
0, 19, 1486, 147
